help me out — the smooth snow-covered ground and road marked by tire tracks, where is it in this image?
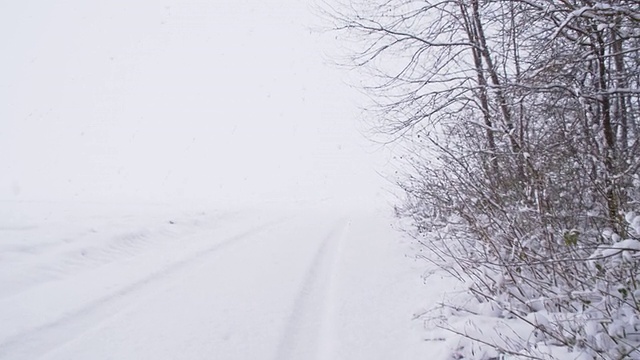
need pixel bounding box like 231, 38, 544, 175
0, 202, 451, 360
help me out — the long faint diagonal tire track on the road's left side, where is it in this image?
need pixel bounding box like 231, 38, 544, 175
0, 218, 290, 360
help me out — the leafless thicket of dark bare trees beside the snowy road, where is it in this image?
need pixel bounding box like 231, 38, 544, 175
325, 0, 640, 358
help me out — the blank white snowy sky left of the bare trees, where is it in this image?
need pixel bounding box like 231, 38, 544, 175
0, 0, 382, 205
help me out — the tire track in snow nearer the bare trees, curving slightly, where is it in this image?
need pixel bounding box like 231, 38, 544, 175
274, 219, 350, 360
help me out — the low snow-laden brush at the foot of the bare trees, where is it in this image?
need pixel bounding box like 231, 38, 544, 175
399, 153, 640, 359
